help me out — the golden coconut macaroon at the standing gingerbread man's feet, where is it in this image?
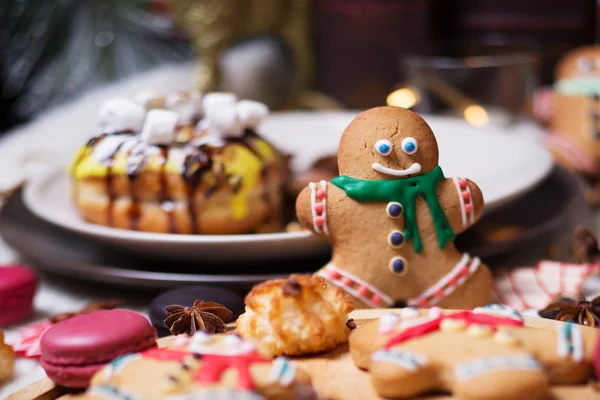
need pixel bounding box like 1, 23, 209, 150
237, 275, 353, 356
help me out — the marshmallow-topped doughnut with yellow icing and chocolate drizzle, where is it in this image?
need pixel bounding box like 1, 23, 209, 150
71, 91, 285, 234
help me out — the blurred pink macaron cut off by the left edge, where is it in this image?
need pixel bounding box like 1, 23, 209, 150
0, 265, 37, 328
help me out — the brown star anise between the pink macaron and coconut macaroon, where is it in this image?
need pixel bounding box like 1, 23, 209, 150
164, 300, 233, 335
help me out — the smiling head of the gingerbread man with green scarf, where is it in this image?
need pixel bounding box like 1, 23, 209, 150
338, 107, 438, 180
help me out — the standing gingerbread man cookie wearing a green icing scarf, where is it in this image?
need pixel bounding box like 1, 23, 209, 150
296, 107, 492, 308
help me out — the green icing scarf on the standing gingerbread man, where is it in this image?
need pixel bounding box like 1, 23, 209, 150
331, 165, 455, 253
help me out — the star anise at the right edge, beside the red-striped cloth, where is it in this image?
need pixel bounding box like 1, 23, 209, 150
539, 296, 600, 327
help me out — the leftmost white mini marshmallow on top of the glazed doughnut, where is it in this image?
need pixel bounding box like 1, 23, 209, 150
98, 97, 146, 133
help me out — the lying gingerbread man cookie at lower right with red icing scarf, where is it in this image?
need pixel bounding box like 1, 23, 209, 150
350, 306, 596, 400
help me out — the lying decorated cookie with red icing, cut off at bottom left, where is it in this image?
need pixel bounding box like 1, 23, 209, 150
68, 332, 315, 400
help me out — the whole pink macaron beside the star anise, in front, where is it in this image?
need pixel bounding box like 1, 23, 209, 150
40, 309, 156, 388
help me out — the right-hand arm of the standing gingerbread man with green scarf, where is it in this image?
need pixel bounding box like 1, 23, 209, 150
437, 178, 483, 235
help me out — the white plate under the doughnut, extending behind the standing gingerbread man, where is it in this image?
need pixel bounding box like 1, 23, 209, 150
24, 112, 553, 262
